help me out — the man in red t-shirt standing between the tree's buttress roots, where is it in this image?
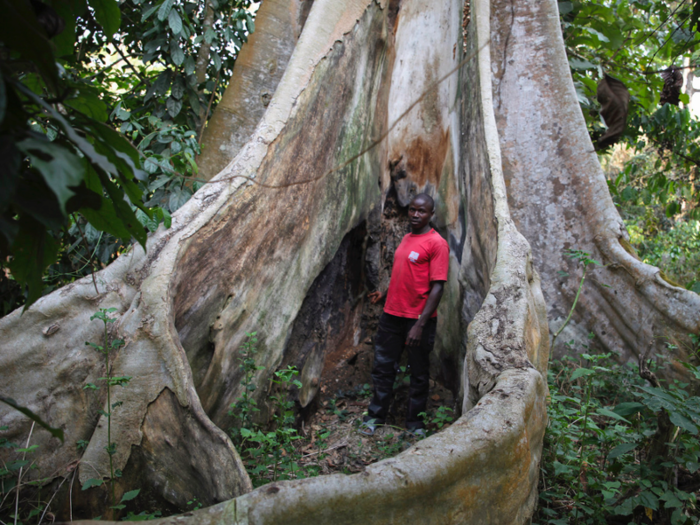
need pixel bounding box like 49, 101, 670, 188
360, 193, 449, 435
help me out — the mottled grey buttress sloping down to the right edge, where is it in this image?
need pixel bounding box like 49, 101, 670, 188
492, 0, 700, 379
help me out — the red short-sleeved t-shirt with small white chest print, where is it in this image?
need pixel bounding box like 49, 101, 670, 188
384, 230, 450, 319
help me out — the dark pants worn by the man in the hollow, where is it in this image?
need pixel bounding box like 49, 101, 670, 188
365, 313, 437, 430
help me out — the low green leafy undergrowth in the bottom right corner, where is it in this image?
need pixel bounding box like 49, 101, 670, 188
533, 348, 700, 525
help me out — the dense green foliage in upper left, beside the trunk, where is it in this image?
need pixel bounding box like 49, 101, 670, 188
0, 0, 255, 315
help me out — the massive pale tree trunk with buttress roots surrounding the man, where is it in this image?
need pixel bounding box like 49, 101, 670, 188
0, 0, 697, 523
